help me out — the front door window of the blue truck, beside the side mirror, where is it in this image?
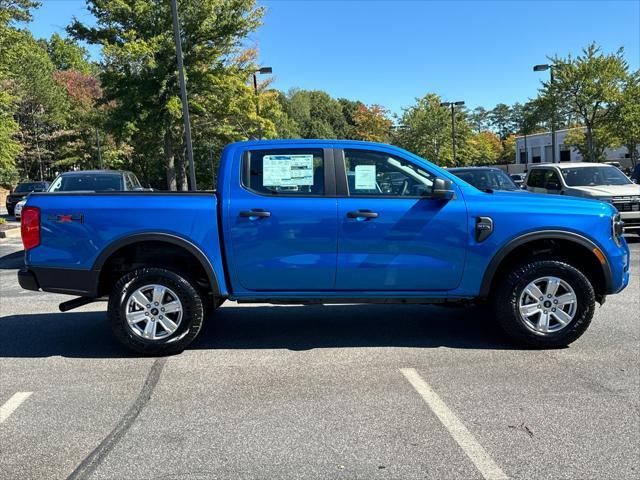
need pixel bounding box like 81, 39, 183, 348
344, 149, 435, 197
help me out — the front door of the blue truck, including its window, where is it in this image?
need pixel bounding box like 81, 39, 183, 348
336, 148, 468, 292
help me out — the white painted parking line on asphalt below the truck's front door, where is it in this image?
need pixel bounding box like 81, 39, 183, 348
400, 368, 509, 480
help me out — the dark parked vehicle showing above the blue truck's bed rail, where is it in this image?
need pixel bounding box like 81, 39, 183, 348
47, 170, 146, 192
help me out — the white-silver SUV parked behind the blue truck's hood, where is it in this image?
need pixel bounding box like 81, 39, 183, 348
525, 163, 640, 233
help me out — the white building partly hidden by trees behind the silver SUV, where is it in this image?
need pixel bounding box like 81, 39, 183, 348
515, 129, 631, 167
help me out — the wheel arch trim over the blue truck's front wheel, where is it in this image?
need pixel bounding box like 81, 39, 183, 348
480, 230, 612, 299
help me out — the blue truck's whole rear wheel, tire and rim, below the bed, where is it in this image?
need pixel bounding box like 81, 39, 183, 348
108, 267, 204, 355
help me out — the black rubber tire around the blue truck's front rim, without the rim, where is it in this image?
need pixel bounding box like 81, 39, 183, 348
493, 260, 596, 348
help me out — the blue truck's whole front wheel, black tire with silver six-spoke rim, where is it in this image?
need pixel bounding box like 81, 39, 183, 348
493, 260, 595, 348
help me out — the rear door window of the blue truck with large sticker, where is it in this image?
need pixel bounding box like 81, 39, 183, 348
242, 149, 325, 196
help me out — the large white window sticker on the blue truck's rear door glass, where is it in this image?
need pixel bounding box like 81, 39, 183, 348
262, 154, 313, 187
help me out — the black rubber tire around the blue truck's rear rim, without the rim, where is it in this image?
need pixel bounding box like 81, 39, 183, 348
108, 267, 204, 356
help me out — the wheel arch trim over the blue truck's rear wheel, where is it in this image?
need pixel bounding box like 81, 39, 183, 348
91, 232, 221, 297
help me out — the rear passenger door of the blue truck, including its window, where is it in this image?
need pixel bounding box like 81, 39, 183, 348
226, 146, 337, 294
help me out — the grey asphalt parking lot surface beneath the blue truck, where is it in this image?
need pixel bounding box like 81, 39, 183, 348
0, 230, 640, 479
